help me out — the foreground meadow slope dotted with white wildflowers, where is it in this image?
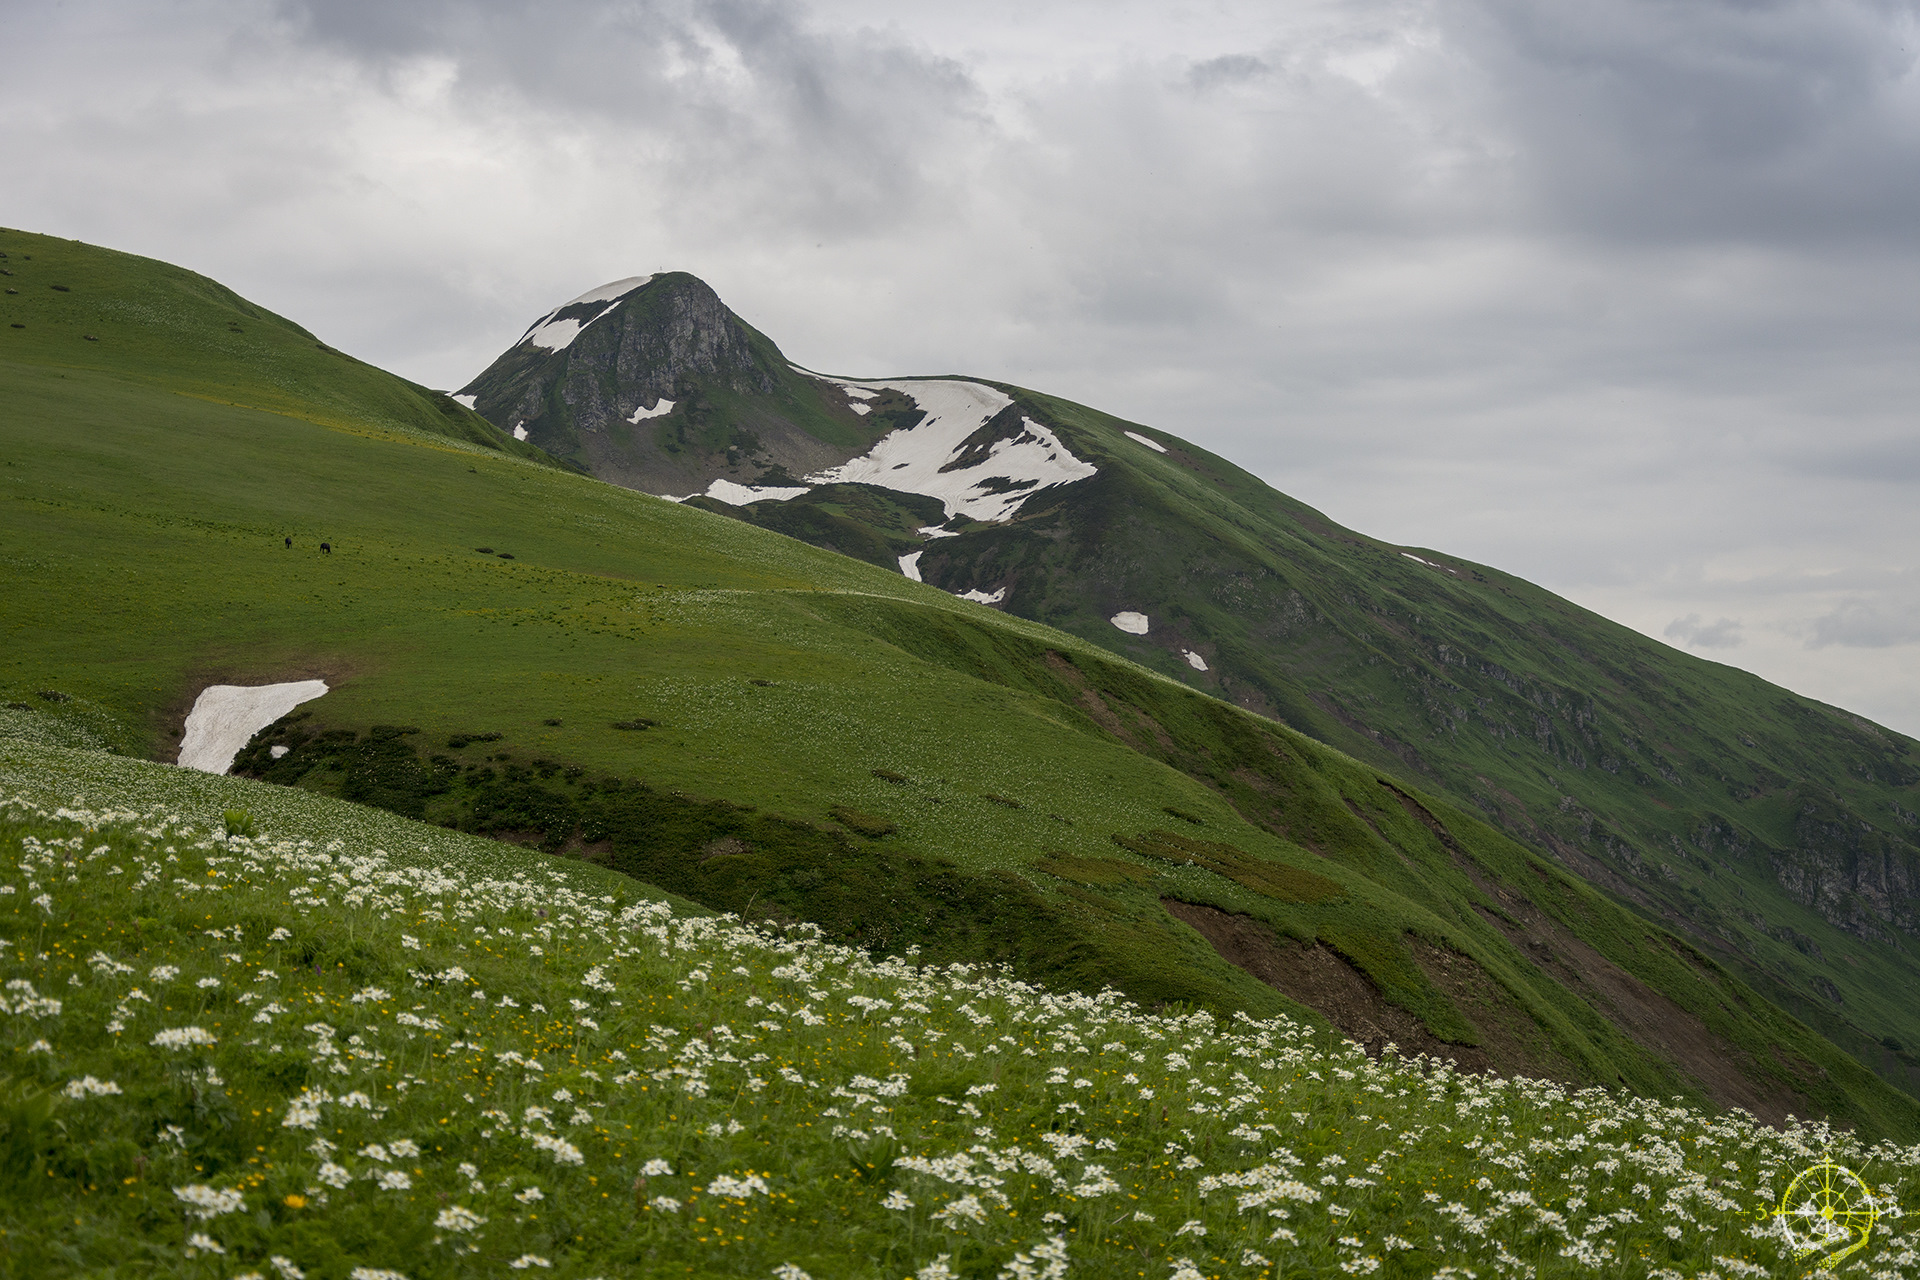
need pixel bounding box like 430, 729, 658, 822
0, 759, 1920, 1280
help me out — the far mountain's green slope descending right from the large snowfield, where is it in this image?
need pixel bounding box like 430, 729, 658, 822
687, 360, 1920, 1090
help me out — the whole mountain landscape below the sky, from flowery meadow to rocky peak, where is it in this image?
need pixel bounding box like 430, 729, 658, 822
0, 230, 1920, 1280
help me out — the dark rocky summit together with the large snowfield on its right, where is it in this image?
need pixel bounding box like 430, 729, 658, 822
463, 273, 1096, 537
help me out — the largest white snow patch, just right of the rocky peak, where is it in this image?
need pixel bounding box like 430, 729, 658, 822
806, 374, 1098, 522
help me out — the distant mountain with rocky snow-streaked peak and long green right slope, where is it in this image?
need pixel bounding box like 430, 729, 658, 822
468, 274, 1920, 1092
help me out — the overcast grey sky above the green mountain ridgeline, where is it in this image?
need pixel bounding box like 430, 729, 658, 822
15, 0, 1920, 735
